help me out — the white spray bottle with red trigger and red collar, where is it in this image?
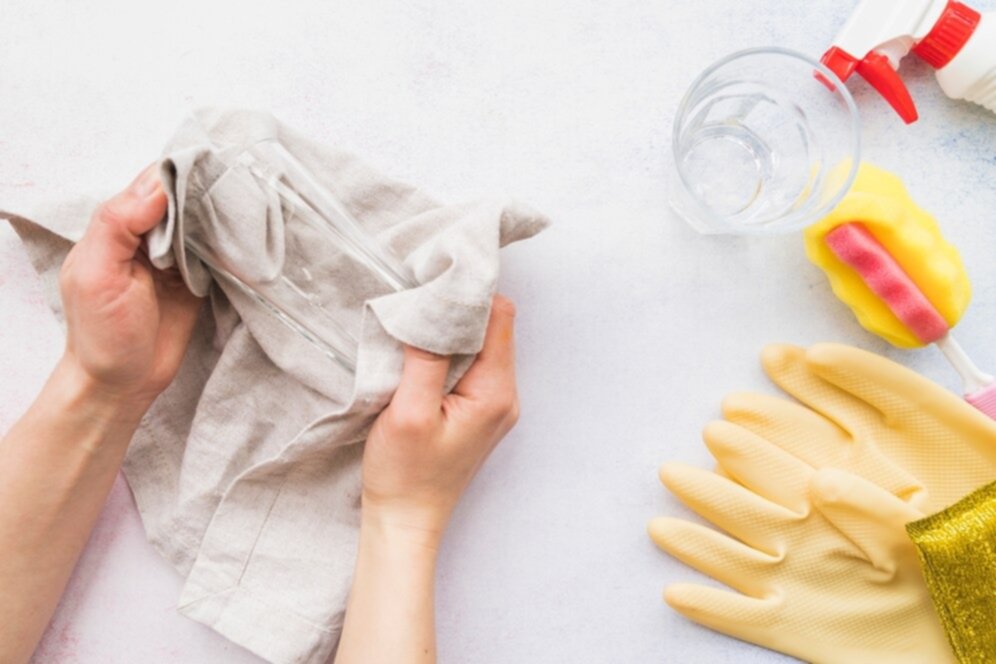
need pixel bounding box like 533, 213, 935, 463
822, 0, 996, 124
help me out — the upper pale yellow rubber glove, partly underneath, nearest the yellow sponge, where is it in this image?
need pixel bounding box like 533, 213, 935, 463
721, 344, 996, 514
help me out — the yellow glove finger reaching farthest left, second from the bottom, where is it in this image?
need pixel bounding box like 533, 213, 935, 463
647, 517, 780, 597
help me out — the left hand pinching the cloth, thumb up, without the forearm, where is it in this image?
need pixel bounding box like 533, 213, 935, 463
59, 165, 200, 412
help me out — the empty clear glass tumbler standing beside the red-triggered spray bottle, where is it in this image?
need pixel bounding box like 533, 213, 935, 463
670, 48, 861, 235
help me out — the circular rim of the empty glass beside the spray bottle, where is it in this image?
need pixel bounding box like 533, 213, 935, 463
671, 46, 861, 235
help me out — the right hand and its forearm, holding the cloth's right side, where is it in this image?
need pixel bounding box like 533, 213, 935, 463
336, 304, 518, 664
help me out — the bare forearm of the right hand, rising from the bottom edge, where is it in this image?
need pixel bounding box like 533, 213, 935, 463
335, 509, 439, 664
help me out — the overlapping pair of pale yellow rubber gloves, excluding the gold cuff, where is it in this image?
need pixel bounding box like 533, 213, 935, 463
649, 344, 996, 664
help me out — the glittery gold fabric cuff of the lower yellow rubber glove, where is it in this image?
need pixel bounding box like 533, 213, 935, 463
906, 482, 996, 664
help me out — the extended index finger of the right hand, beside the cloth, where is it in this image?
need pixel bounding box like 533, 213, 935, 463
453, 295, 516, 399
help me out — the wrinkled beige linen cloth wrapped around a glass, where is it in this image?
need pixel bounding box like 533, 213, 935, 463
0, 110, 547, 662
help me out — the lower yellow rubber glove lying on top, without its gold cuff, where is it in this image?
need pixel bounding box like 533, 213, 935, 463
649, 454, 955, 664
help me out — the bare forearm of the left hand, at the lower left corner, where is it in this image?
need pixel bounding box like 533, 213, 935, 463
0, 360, 144, 663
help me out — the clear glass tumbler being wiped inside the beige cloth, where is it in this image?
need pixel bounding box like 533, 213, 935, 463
184, 140, 417, 372
